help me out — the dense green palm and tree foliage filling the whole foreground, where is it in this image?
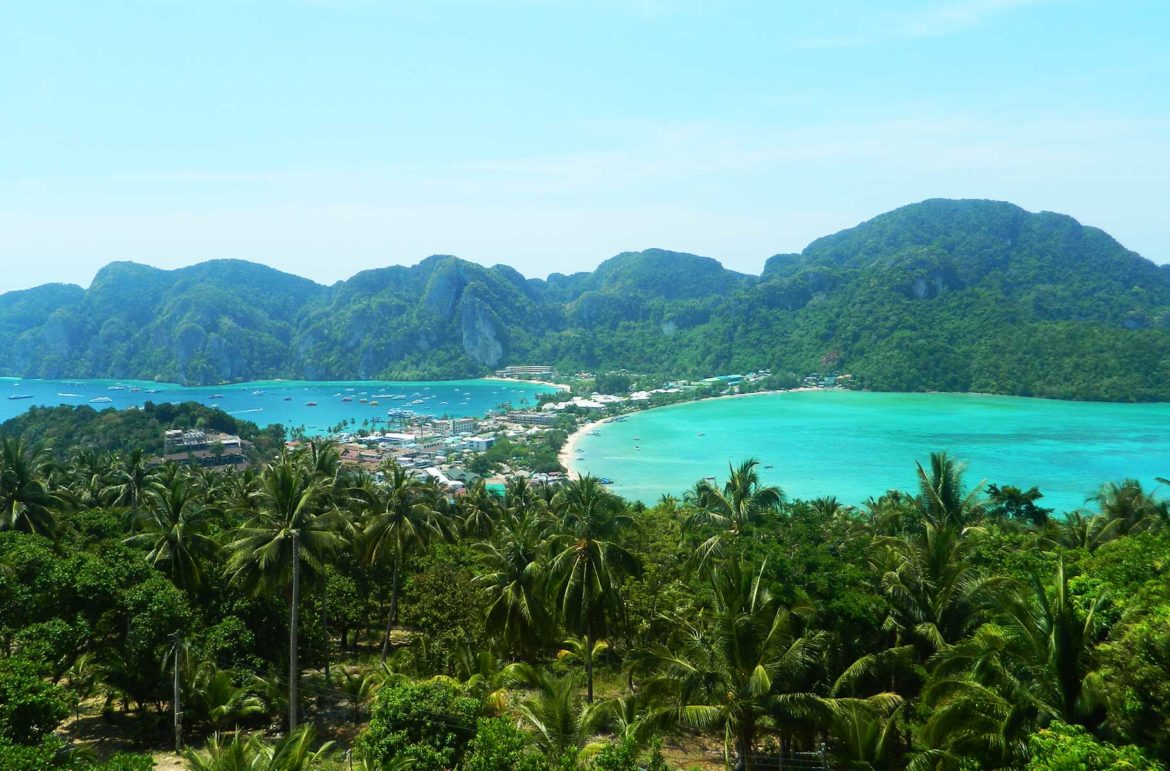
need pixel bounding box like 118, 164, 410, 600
0, 407, 1170, 771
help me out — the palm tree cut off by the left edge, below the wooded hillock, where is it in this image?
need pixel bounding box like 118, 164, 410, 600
0, 436, 68, 537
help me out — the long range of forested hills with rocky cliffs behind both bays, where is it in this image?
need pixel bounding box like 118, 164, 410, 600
0, 200, 1170, 400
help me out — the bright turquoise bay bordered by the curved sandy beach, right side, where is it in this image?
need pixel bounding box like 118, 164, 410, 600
574, 391, 1170, 511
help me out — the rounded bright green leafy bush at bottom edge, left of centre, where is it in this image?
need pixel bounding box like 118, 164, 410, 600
359, 682, 480, 771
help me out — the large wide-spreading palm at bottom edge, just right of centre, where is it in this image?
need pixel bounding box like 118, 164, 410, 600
648, 559, 827, 770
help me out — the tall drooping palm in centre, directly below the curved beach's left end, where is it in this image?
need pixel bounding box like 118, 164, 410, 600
549, 476, 641, 704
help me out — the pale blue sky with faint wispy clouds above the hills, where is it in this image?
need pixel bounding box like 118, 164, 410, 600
0, 0, 1170, 291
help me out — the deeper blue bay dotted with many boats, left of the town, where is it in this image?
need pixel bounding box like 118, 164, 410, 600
0, 378, 553, 434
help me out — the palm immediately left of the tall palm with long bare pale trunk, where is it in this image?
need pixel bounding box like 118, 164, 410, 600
124, 476, 219, 592
